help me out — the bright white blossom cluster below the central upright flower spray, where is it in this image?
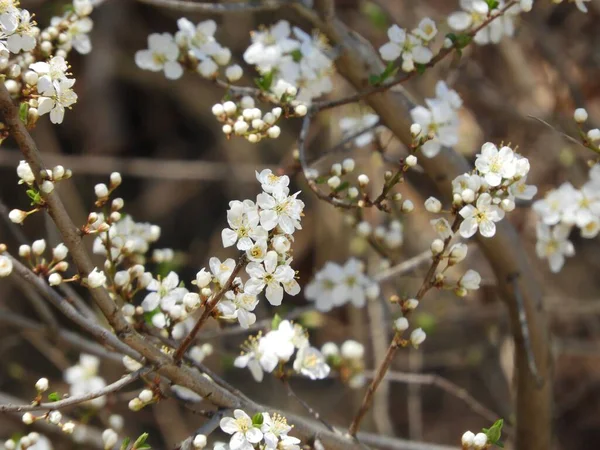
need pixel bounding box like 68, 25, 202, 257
234, 320, 331, 382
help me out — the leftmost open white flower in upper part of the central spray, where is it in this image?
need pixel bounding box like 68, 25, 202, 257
221, 200, 267, 251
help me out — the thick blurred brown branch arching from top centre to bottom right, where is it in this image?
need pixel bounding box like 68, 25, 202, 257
296, 2, 552, 450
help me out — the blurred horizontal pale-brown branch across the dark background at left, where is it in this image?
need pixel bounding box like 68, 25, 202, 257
0, 149, 275, 182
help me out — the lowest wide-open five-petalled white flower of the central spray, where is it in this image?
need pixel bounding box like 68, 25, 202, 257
245, 250, 300, 306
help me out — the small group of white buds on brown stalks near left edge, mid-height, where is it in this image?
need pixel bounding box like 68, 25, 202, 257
19, 239, 74, 286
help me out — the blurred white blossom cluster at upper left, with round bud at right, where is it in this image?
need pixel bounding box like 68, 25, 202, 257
135, 17, 243, 81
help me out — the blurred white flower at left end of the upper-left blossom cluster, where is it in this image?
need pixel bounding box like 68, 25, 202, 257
135, 33, 183, 80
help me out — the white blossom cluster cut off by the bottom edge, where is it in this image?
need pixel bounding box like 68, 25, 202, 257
218, 409, 301, 450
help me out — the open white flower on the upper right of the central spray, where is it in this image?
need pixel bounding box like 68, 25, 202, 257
256, 188, 304, 234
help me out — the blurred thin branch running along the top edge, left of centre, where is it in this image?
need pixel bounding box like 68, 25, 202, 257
138, 0, 299, 14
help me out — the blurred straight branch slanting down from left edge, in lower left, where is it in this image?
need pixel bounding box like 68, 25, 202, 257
0, 308, 123, 364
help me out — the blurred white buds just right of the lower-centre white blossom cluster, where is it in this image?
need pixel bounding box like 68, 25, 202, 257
321, 340, 366, 389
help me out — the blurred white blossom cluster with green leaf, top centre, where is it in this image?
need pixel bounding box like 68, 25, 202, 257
244, 20, 333, 103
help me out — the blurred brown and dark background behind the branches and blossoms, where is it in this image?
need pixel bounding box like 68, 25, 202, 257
0, 0, 600, 450
